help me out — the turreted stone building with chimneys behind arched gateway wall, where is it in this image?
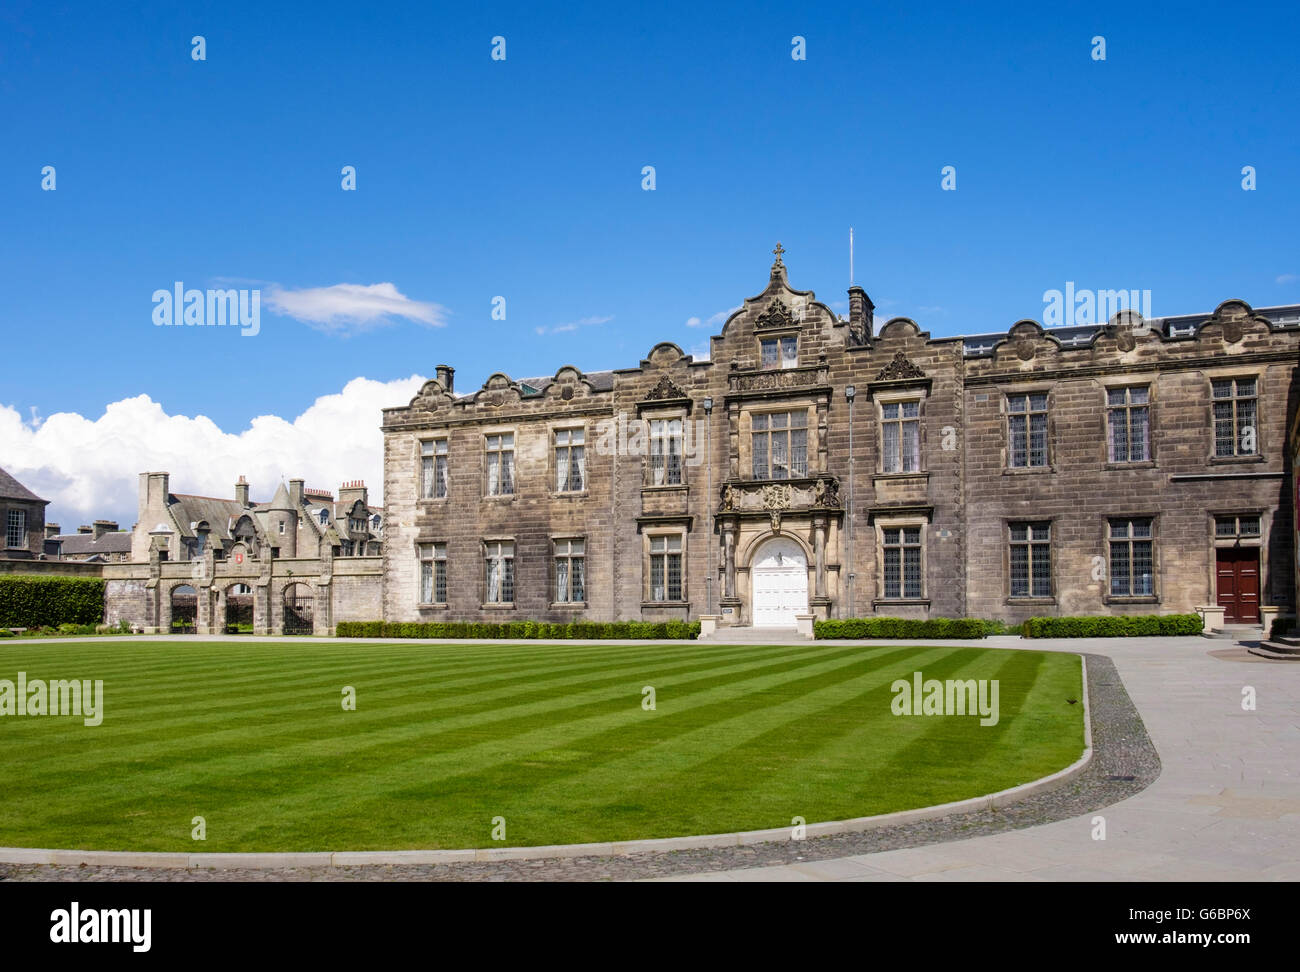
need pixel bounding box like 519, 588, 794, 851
103, 472, 384, 634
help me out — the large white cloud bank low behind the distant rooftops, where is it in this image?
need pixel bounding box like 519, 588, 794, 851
0, 374, 426, 533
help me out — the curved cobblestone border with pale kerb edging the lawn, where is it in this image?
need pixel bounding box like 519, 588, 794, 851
0, 654, 1160, 881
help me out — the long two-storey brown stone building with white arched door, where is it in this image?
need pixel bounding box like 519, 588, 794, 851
376, 246, 1300, 626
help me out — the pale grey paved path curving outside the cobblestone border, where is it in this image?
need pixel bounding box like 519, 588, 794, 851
663, 638, 1300, 881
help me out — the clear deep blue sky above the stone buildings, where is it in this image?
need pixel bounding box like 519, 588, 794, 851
0, 0, 1300, 527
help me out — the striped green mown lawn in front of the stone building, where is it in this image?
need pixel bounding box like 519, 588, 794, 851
0, 639, 1083, 851
